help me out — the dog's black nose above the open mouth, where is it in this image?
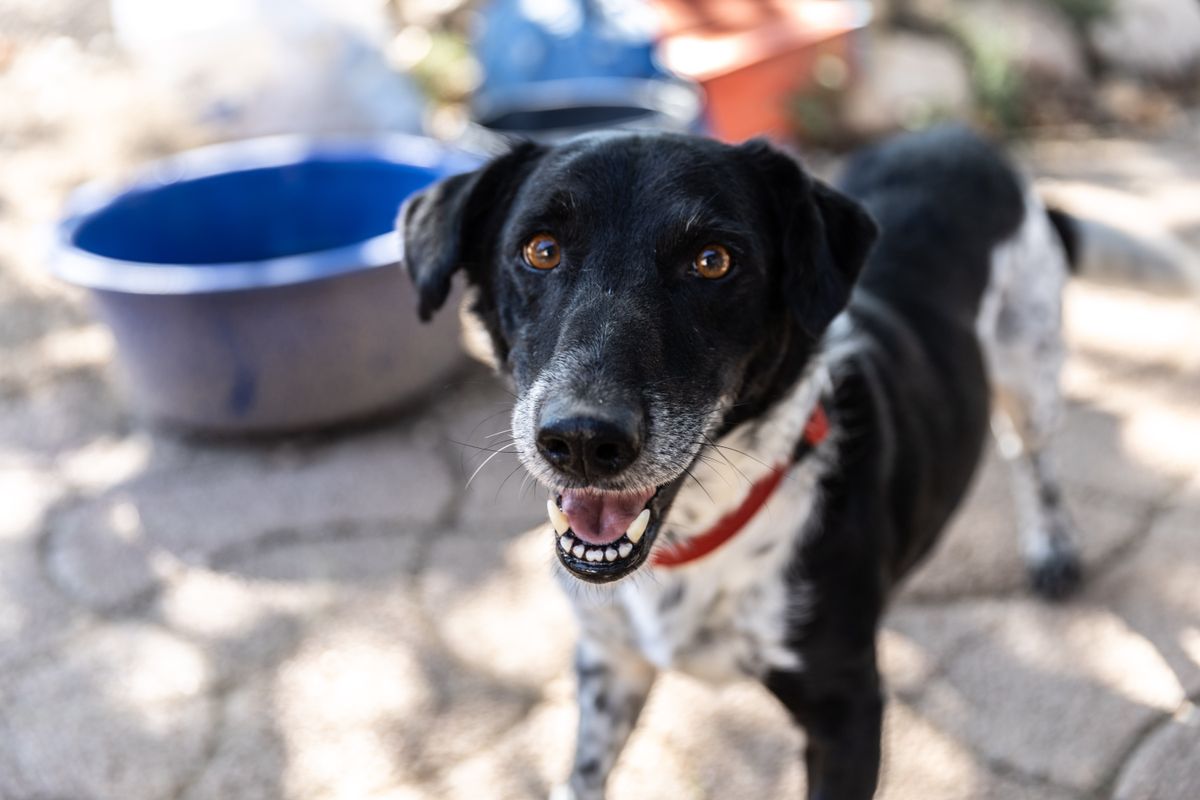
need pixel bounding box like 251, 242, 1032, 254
538, 402, 642, 480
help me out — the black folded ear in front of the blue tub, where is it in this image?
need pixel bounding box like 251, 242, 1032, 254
396, 143, 544, 321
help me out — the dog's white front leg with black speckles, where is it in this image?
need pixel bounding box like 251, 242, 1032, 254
552, 638, 655, 800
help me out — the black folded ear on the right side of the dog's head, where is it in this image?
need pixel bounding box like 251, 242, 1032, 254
740, 139, 878, 339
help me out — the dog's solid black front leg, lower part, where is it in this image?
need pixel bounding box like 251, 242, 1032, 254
767, 658, 883, 800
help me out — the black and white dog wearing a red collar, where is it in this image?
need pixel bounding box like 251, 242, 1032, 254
397, 127, 1080, 800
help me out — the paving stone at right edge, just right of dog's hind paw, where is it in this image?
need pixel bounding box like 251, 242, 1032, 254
1087, 479, 1200, 697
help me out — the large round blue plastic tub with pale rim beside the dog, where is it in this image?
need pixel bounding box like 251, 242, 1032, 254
52, 136, 478, 433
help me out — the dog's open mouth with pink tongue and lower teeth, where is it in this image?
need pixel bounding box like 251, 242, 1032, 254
546, 488, 661, 583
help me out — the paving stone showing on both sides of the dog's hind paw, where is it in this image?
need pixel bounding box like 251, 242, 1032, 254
901, 443, 1150, 601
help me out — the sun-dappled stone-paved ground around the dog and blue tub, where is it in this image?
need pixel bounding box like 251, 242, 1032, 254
0, 31, 1200, 800
